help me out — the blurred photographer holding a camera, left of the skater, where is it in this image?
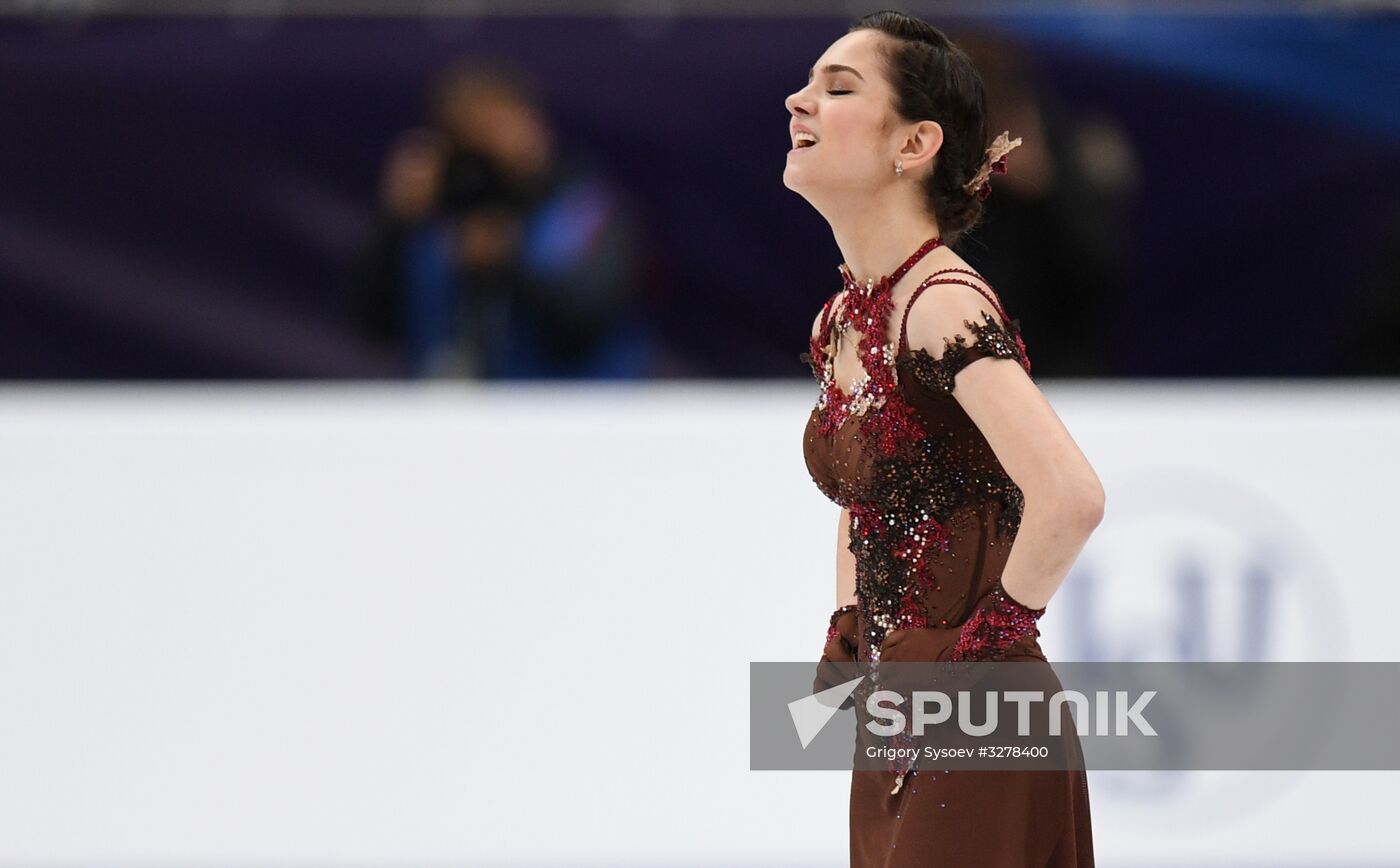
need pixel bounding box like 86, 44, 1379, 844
356, 57, 650, 378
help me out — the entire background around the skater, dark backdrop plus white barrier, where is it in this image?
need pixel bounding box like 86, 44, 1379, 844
0, 0, 1400, 865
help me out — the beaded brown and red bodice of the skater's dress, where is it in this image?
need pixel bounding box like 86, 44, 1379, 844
802, 272, 1033, 659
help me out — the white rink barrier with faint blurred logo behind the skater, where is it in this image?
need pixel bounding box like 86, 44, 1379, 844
0, 382, 1400, 867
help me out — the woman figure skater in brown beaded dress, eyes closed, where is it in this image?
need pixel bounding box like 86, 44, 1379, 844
783, 11, 1103, 868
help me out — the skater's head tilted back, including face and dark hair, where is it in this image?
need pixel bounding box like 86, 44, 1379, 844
783, 11, 990, 244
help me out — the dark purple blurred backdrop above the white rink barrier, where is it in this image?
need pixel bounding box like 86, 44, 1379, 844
8, 3, 1400, 379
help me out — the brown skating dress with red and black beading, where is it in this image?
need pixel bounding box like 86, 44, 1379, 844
802, 266, 1093, 868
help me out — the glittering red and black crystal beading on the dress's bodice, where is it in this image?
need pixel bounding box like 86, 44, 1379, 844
801, 254, 1030, 664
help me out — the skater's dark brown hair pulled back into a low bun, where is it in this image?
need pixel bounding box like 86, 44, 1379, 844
847, 10, 991, 244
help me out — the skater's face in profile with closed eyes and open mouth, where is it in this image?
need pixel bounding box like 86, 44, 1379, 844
783, 29, 899, 193
